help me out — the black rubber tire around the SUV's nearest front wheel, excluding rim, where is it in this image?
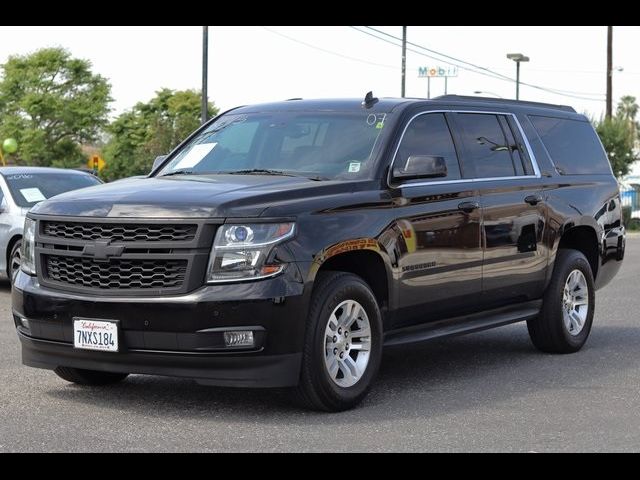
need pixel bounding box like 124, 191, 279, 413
301, 272, 382, 411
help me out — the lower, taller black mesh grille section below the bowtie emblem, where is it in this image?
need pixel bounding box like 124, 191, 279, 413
44, 255, 188, 290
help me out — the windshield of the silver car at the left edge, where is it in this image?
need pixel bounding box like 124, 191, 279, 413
4, 173, 101, 207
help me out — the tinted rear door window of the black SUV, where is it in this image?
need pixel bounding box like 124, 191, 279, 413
456, 113, 524, 178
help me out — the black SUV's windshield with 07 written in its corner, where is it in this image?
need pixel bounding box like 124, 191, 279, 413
159, 111, 386, 180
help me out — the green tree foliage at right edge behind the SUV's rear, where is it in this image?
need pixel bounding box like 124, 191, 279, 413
595, 95, 640, 178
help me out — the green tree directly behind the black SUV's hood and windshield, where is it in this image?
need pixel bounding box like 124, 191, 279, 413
102, 88, 218, 180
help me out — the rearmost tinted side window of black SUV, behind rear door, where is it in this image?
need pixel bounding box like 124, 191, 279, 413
529, 115, 611, 175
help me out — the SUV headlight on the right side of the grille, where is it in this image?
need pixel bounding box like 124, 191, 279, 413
207, 223, 295, 282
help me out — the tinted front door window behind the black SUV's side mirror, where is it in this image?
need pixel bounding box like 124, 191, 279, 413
394, 113, 460, 182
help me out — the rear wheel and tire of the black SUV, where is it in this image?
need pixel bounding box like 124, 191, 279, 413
527, 249, 595, 353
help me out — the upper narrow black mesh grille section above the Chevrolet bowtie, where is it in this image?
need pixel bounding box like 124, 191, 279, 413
42, 221, 198, 242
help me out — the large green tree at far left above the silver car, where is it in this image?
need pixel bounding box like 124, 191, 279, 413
0, 48, 111, 167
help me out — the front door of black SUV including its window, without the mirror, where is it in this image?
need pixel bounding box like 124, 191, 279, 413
392, 112, 482, 328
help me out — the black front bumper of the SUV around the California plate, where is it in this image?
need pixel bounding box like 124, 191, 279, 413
12, 272, 307, 387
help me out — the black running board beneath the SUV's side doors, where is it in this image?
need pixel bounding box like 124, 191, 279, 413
384, 300, 542, 347
